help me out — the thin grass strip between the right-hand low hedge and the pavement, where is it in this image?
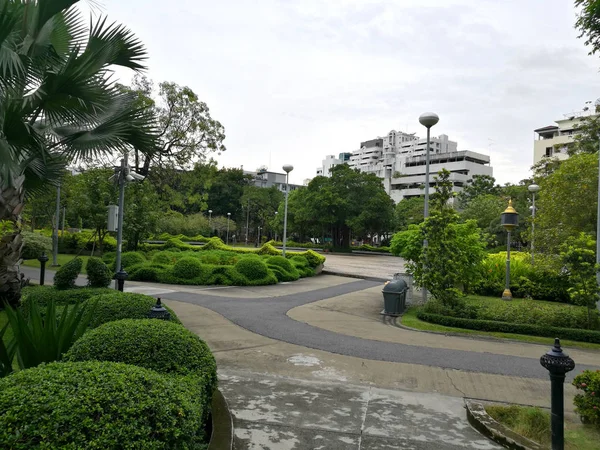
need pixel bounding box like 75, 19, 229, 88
401, 306, 600, 350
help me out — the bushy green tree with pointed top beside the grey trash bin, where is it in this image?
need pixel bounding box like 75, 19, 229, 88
391, 169, 485, 308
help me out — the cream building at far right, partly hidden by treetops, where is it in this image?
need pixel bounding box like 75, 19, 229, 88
533, 102, 594, 165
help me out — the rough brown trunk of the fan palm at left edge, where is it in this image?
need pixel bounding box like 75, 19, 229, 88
0, 175, 25, 306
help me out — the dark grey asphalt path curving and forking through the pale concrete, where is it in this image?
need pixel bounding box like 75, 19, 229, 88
159, 280, 596, 379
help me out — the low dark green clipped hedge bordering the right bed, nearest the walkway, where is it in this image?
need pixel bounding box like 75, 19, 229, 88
417, 311, 600, 344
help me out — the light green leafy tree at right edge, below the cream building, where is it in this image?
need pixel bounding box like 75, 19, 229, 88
536, 153, 598, 254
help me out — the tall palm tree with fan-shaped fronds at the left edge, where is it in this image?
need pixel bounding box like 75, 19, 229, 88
0, 0, 155, 303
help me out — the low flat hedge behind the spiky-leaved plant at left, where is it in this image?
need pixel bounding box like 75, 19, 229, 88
21, 286, 115, 316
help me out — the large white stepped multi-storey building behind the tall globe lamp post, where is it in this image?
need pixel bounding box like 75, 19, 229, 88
348, 130, 493, 202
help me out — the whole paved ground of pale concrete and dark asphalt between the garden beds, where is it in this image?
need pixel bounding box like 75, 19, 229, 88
19, 266, 600, 450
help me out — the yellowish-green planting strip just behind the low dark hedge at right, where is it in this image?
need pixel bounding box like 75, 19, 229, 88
425, 298, 600, 330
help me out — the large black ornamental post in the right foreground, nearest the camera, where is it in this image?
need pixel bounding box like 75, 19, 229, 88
540, 338, 575, 450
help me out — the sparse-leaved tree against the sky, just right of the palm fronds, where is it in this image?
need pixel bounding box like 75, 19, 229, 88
120, 76, 225, 175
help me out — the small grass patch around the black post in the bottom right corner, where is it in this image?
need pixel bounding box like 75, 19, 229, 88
486, 405, 600, 450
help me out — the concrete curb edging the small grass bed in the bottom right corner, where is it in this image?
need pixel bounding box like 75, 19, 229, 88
466, 400, 543, 450
